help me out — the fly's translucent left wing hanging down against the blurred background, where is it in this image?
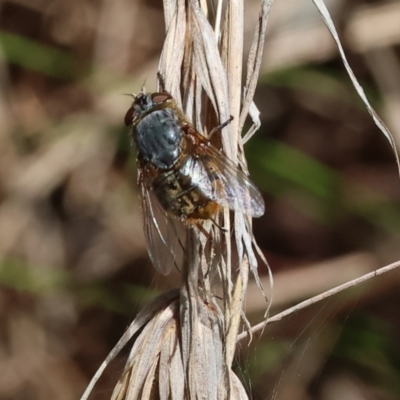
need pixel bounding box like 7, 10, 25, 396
138, 171, 185, 275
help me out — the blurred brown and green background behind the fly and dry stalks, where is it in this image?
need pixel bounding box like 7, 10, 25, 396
0, 0, 400, 400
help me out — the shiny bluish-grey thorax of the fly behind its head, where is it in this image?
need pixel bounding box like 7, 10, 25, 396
133, 104, 182, 170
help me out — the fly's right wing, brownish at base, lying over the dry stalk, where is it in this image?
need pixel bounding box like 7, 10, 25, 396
191, 132, 265, 218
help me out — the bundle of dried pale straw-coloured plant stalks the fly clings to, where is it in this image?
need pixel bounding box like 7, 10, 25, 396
82, 0, 270, 400
